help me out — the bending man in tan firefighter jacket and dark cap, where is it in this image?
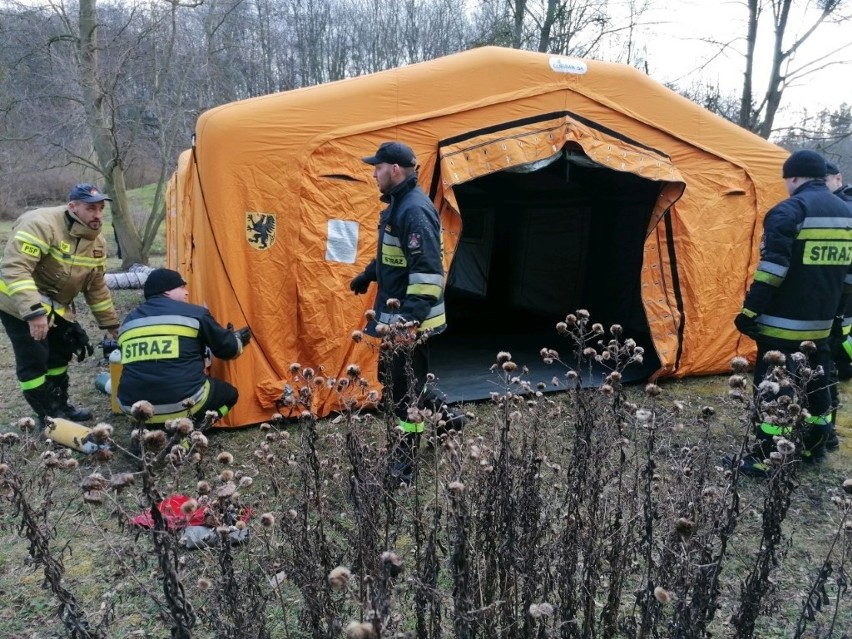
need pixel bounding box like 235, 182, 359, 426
0, 184, 119, 428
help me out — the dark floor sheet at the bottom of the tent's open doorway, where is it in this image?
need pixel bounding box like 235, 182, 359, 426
430, 330, 659, 403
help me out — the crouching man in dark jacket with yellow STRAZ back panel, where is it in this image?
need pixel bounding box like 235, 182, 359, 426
118, 268, 251, 424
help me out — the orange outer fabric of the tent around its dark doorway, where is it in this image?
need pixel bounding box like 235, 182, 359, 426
167, 47, 786, 426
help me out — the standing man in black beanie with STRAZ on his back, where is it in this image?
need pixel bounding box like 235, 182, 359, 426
735, 150, 852, 476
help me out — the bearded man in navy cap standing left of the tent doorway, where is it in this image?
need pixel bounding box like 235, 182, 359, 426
349, 142, 465, 483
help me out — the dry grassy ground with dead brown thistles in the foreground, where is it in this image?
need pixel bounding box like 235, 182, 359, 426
0, 238, 852, 639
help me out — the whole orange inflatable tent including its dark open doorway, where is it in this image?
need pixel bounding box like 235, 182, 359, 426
167, 47, 787, 427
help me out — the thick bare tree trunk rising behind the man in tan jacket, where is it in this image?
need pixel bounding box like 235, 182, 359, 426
77, 0, 145, 268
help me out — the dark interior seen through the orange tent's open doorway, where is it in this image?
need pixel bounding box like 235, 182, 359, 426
430, 151, 660, 402
